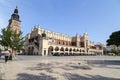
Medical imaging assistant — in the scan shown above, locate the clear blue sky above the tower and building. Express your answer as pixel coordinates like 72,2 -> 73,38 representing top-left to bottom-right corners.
0,0 -> 120,44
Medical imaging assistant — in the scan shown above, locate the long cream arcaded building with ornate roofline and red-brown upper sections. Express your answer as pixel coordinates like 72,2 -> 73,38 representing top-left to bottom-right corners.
25,26 -> 103,56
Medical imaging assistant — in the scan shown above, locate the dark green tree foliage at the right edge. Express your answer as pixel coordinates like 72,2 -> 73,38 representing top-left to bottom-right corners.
106,31 -> 120,47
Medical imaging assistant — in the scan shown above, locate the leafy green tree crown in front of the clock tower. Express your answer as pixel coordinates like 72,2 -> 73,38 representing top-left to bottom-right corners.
0,28 -> 24,50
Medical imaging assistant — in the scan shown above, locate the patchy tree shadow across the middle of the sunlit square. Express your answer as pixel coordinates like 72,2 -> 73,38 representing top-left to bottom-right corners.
27,63 -> 92,73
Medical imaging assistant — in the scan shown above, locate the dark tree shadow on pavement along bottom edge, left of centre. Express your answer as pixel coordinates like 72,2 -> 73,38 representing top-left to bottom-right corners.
17,73 -> 56,80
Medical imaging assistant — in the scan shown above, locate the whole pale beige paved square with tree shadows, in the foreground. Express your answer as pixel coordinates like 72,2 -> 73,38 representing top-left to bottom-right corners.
0,56 -> 120,80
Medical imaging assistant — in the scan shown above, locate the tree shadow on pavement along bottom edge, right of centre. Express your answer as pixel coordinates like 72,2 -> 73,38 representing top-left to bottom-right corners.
63,73 -> 120,80
